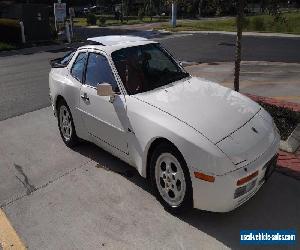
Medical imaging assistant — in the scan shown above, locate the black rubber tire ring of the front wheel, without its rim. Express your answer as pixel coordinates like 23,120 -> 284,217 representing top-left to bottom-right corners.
150,143 -> 193,214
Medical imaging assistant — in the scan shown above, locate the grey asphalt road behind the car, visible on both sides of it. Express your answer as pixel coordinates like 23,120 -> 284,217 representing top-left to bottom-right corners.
0,31 -> 300,120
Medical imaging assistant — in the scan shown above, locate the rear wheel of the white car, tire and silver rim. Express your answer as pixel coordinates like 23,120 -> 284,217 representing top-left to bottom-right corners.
57,101 -> 79,148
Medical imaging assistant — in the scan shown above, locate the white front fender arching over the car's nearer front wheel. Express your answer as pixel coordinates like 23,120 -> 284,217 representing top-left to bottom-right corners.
126,94 -> 234,176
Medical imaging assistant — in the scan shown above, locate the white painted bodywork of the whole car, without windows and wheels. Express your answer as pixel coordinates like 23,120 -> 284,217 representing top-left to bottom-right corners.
49,38 -> 279,212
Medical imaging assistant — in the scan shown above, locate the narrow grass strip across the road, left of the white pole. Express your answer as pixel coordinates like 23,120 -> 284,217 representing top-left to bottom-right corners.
74,17 -> 166,27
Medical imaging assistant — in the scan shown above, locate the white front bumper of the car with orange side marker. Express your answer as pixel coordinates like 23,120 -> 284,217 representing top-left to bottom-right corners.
191,131 -> 280,212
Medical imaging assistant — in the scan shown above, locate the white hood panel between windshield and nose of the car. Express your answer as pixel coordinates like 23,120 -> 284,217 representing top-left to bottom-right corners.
135,77 -> 260,144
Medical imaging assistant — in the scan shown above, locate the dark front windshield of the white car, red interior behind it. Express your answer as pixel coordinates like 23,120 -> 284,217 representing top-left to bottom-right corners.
112,44 -> 189,95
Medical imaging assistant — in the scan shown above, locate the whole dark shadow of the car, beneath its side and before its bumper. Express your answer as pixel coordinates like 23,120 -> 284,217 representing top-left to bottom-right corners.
75,142 -> 300,249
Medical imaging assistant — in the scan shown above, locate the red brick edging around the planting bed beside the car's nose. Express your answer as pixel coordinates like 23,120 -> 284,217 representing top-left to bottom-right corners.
246,94 -> 300,180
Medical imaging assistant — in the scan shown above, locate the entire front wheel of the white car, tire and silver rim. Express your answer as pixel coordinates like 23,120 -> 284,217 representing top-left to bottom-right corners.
150,143 -> 193,214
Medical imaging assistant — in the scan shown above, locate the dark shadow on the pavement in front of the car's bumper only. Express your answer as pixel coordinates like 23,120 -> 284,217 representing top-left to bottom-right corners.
178,172 -> 300,249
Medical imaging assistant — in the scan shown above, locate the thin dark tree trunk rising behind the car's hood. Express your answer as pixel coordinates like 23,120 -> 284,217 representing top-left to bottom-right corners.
234,0 -> 245,91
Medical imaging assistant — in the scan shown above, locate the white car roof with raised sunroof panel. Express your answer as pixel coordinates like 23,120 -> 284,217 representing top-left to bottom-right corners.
78,35 -> 157,54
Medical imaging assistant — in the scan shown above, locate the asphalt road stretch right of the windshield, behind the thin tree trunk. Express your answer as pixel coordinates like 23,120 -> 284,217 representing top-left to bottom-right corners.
162,34 -> 300,63
